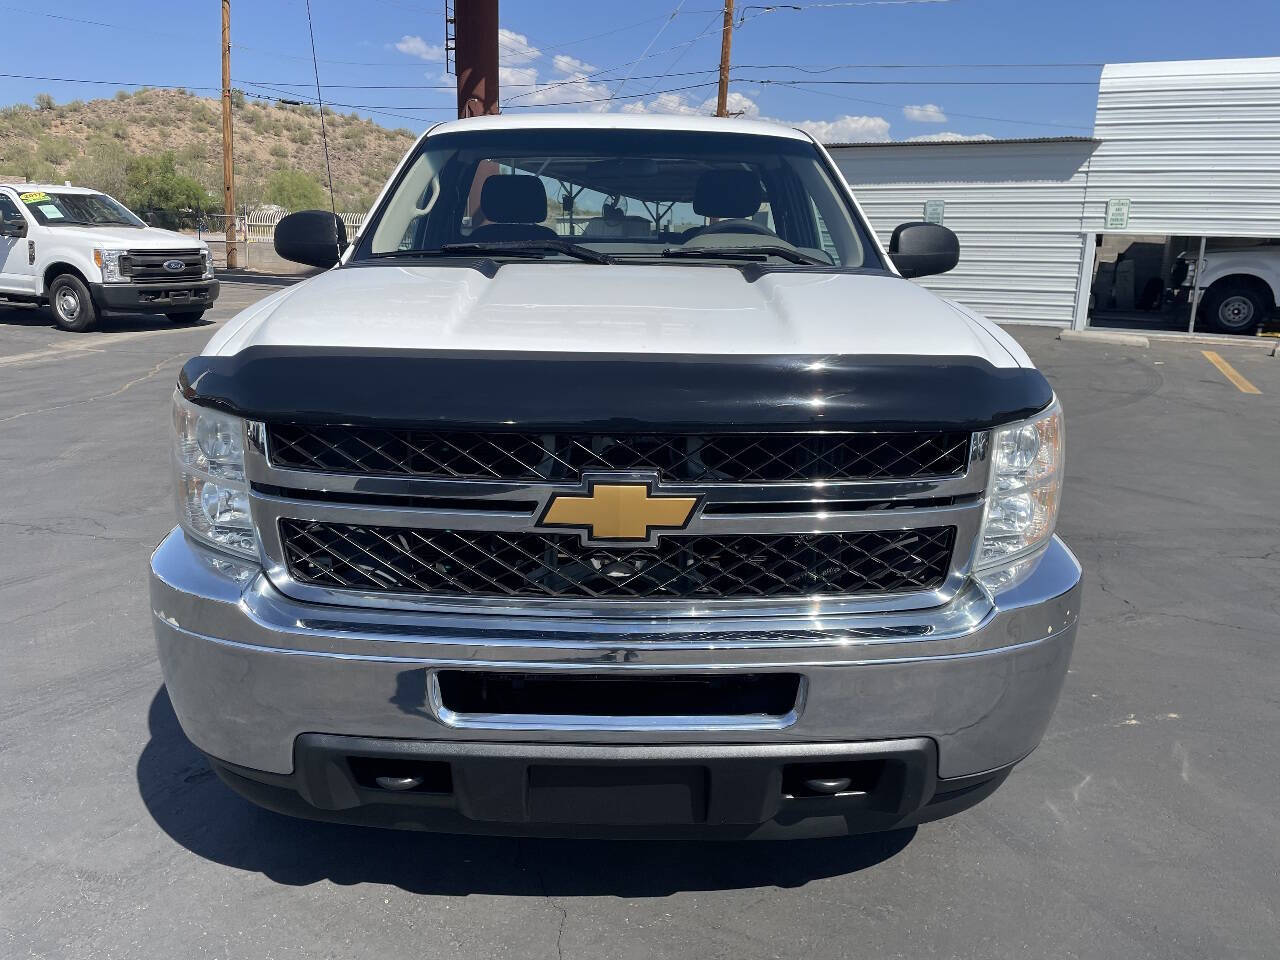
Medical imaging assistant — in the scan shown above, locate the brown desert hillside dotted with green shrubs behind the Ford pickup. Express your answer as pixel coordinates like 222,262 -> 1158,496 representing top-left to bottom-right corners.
0,90 -> 413,212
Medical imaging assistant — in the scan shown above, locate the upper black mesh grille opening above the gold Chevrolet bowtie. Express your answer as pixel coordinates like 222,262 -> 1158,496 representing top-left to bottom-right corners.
269,424 -> 969,483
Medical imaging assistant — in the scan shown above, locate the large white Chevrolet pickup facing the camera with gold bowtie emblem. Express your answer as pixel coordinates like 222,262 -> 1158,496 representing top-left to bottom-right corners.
151,114 -> 1080,837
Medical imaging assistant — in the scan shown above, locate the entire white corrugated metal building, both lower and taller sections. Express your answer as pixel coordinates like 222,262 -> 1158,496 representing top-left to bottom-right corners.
828,58 -> 1280,335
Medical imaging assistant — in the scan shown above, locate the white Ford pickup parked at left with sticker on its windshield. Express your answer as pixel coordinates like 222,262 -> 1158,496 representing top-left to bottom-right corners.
0,183 -> 218,333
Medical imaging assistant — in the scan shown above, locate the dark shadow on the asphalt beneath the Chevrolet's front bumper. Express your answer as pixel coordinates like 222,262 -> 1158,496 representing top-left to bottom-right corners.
137,687 -> 915,897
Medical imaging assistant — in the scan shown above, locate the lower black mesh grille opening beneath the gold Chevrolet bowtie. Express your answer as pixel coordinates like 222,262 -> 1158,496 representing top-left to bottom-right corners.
279,518 -> 955,599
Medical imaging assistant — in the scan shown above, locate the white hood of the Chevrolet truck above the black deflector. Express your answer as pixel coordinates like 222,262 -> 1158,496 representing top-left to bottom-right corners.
205,262 -> 1020,367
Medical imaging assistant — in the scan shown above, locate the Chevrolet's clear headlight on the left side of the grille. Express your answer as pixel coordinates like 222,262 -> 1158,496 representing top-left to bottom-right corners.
173,392 -> 257,559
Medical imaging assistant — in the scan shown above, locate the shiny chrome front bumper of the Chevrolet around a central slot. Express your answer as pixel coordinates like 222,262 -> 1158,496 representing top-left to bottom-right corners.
151,530 -> 1080,778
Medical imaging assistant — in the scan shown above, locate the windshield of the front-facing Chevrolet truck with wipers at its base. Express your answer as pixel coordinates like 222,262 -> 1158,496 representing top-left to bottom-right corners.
353,129 -> 883,270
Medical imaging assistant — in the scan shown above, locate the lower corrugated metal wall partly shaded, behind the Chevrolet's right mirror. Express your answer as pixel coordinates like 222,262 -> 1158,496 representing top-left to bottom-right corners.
828,140 -> 1096,325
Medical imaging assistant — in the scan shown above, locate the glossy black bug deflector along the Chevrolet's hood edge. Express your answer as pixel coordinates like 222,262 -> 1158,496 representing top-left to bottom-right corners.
178,346 -> 1053,433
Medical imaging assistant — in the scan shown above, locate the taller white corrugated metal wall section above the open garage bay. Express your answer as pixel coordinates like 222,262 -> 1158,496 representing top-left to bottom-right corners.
1085,58 -> 1280,237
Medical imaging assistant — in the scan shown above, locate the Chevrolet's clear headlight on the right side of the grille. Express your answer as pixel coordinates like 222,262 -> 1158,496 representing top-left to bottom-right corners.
975,399 -> 1064,570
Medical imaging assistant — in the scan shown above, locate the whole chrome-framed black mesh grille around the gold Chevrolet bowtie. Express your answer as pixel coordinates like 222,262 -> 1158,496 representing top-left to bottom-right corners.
246,422 -> 989,618
